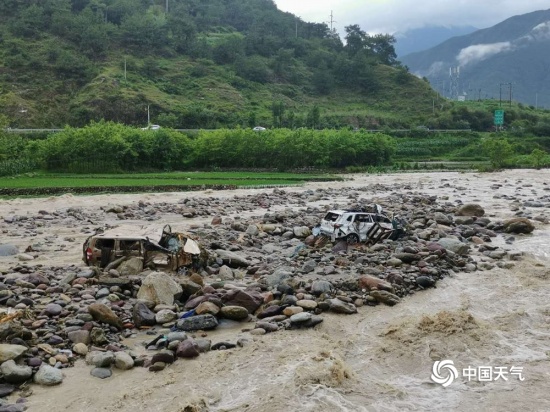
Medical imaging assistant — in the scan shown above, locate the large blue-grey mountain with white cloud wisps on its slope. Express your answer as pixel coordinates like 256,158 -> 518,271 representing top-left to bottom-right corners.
401,9 -> 550,108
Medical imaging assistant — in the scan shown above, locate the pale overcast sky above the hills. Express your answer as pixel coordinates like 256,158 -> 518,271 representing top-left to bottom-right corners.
274,0 -> 550,37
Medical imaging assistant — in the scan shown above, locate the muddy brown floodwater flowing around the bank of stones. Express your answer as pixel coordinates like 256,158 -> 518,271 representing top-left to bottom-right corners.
0,170 -> 550,412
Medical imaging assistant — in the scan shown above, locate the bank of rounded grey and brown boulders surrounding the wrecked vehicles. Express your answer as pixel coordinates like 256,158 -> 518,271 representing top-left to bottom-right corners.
0,176 -> 548,406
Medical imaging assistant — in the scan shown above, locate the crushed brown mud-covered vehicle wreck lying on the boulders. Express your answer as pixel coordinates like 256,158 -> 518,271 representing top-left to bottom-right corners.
82,225 -> 208,272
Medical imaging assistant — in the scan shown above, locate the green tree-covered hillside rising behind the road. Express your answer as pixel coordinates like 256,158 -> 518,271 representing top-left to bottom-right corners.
0,0 -> 440,128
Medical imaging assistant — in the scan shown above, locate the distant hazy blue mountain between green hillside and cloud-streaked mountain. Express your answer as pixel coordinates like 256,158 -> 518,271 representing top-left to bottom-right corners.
394,26 -> 478,58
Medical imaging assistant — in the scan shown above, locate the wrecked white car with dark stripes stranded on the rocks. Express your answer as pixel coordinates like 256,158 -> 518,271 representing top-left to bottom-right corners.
314,205 -> 406,244
